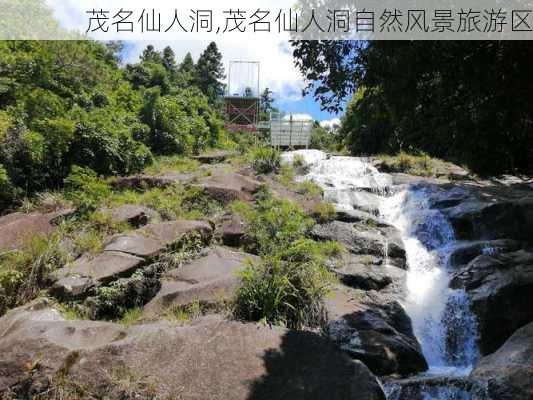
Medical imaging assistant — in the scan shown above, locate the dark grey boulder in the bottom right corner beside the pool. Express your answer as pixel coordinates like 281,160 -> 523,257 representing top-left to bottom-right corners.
470,323 -> 533,400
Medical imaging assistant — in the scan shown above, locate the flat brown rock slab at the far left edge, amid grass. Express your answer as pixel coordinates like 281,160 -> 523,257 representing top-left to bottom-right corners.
0,210 -> 72,251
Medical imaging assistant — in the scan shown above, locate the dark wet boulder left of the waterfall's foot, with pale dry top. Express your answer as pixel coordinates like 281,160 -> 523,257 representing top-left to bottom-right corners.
326,288 -> 428,376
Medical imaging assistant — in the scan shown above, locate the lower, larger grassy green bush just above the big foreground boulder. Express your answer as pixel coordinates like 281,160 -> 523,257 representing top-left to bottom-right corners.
235,239 -> 341,329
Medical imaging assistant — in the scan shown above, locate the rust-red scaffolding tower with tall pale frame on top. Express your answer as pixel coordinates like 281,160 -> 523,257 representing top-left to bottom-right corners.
224,61 -> 261,132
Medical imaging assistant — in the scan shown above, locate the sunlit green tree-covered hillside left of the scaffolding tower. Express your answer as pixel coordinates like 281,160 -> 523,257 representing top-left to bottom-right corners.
0,41 -> 223,208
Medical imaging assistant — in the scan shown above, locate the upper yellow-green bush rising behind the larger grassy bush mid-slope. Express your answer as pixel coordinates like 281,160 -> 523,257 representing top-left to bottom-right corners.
234,196 -> 313,255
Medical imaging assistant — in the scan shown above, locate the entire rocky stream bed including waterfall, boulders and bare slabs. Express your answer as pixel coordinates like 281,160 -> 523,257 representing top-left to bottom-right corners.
0,150 -> 533,400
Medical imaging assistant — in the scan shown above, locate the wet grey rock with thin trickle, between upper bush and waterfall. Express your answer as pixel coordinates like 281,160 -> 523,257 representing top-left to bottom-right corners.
311,221 -> 406,268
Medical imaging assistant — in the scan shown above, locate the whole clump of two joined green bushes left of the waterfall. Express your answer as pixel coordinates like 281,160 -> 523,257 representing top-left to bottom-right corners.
234,192 -> 342,329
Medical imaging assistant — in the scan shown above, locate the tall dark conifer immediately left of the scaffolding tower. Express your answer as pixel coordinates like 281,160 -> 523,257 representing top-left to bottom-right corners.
195,42 -> 226,104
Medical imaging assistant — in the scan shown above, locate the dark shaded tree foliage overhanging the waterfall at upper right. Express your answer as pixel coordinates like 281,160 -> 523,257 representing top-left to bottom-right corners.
294,40 -> 533,174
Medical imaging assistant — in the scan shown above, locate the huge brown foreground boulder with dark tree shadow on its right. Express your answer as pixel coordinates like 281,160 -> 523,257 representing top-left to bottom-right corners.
0,304 -> 385,400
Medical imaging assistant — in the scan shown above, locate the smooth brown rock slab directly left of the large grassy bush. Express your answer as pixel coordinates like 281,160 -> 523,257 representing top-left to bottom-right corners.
144,246 -> 257,316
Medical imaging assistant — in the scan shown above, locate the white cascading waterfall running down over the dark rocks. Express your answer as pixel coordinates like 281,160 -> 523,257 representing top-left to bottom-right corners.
283,150 -> 478,400
